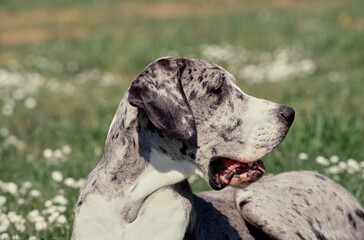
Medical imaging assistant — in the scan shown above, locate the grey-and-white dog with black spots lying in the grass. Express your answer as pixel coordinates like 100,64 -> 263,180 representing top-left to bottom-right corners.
72,57 -> 364,240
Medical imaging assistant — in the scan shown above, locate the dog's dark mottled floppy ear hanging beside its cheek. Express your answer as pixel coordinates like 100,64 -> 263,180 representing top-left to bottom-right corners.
128,58 -> 196,140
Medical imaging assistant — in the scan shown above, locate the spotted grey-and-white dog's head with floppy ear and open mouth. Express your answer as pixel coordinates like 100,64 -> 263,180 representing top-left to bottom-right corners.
129,57 -> 294,190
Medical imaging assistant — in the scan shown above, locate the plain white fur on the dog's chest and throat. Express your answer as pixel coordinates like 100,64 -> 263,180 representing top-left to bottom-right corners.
74,149 -> 198,240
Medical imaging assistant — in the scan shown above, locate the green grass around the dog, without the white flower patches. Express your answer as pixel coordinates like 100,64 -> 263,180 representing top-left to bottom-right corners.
0,0 -> 364,239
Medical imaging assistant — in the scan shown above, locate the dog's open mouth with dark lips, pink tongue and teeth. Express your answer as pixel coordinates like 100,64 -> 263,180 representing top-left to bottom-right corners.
209,157 -> 267,190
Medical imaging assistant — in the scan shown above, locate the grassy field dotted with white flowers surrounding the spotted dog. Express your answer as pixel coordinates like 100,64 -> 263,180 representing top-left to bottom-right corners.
0,0 -> 364,239
